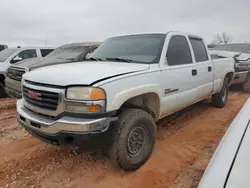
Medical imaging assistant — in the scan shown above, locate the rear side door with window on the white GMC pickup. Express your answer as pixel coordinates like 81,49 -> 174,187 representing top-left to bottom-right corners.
189,36 -> 214,101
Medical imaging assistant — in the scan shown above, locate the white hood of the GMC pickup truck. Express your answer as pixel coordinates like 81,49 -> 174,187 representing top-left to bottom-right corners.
23,61 -> 149,86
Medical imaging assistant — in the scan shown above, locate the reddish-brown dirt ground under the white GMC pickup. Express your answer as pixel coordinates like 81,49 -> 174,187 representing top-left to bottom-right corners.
0,91 -> 248,188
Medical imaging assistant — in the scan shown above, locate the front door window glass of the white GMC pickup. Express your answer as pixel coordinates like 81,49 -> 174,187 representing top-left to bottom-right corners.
167,35 -> 193,66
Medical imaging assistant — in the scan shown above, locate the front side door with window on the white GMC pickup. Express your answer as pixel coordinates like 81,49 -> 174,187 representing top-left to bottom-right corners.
162,35 -> 197,116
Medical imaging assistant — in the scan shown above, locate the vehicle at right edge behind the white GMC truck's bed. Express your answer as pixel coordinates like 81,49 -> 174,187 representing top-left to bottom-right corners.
211,43 -> 250,92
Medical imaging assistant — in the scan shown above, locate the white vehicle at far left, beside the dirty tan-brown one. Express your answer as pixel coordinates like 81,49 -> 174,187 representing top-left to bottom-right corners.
0,47 -> 54,98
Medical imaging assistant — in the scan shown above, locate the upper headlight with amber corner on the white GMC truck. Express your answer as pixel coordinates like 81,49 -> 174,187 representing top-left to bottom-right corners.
66,87 -> 106,101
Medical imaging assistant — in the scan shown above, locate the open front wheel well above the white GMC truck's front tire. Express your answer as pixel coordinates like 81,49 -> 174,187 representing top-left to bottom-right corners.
121,93 -> 160,119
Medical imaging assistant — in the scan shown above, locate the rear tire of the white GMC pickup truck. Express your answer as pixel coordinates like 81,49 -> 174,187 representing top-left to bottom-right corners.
212,77 -> 228,108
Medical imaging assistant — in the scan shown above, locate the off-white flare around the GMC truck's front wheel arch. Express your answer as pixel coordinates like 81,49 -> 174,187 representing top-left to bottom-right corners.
112,84 -> 162,109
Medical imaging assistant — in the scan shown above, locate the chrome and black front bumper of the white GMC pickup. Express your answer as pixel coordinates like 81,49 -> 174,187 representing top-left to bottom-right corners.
17,99 -> 117,148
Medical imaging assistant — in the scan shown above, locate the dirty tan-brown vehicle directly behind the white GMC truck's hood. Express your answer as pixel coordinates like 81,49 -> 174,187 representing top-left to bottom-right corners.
5,42 -> 100,98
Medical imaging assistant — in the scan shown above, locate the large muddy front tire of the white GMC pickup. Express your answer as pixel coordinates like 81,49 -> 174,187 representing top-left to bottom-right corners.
109,109 -> 156,171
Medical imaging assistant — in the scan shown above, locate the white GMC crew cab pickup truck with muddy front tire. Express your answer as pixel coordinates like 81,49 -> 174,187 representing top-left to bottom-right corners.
17,32 -> 234,171
